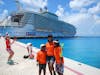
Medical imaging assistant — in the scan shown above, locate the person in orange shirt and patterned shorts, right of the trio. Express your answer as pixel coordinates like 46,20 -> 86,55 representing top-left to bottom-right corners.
54,41 -> 64,75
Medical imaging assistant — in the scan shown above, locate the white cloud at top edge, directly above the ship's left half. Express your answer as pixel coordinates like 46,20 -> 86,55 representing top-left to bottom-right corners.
19,0 -> 47,11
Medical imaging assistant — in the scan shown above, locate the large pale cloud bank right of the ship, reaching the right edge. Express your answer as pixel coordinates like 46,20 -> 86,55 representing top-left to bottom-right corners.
56,3 -> 100,36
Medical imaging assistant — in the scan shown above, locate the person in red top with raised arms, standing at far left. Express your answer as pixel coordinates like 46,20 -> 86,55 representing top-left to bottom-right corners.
5,36 -> 16,64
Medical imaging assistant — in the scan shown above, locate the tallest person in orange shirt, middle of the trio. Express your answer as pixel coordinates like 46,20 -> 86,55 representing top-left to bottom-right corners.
46,35 -> 56,75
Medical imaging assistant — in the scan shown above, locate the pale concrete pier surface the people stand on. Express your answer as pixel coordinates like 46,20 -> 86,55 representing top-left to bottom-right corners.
0,37 -> 100,75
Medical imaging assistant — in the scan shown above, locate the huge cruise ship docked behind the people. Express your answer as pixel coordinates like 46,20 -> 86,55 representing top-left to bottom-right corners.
0,1 -> 76,37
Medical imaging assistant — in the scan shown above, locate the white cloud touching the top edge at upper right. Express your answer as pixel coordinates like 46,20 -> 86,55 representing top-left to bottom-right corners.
69,0 -> 95,9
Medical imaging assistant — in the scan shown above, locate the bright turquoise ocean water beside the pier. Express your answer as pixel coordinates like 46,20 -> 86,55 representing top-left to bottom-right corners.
18,37 -> 100,69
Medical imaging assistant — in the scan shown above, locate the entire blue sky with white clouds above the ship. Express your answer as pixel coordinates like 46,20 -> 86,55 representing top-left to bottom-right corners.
0,0 -> 100,36
